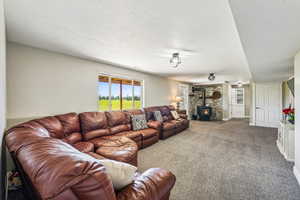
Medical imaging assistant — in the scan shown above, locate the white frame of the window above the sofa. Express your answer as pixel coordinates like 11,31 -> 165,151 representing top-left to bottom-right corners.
97,73 -> 145,112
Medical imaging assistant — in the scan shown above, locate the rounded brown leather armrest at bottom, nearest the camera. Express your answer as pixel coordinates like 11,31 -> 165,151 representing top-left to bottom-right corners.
117,168 -> 176,200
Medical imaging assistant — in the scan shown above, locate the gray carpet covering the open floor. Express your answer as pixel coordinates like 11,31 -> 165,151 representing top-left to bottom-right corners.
139,120 -> 300,200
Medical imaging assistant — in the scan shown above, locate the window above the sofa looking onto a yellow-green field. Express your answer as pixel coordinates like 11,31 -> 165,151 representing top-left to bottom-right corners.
98,76 -> 143,111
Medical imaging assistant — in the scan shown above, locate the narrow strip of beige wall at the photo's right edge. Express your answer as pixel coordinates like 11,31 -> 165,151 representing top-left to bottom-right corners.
294,52 -> 300,184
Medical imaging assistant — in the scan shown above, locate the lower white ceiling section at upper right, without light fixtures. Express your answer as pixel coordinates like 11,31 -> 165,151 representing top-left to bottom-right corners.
230,0 -> 300,81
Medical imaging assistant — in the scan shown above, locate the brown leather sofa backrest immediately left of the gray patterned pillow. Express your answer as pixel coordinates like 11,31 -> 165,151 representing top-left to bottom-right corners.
105,111 -> 131,134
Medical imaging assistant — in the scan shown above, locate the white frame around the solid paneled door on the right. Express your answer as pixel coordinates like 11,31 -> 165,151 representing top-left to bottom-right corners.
249,82 -> 282,128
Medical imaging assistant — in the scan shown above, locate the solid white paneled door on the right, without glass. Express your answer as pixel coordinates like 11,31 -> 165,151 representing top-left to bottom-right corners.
255,83 -> 281,127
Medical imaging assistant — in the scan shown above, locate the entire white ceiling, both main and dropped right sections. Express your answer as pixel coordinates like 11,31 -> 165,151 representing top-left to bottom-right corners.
5,0 -> 300,83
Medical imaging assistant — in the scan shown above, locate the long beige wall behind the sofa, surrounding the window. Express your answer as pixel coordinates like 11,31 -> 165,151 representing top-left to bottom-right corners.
7,43 -> 178,119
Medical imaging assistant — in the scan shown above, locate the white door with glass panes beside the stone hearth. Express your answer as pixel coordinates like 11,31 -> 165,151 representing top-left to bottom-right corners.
231,88 -> 245,118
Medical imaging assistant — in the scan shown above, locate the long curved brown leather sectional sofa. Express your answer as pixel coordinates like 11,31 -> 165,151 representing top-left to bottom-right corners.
6,106 -> 189,200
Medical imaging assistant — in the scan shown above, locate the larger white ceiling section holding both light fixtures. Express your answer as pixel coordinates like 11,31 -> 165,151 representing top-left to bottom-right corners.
5,0 -> 251,82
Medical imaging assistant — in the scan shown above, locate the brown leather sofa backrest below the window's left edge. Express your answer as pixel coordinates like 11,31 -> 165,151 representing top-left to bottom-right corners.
79,112 -> 110,140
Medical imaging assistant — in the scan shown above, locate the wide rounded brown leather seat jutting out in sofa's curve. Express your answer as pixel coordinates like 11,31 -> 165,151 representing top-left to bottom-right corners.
96,137 -> 138,166
